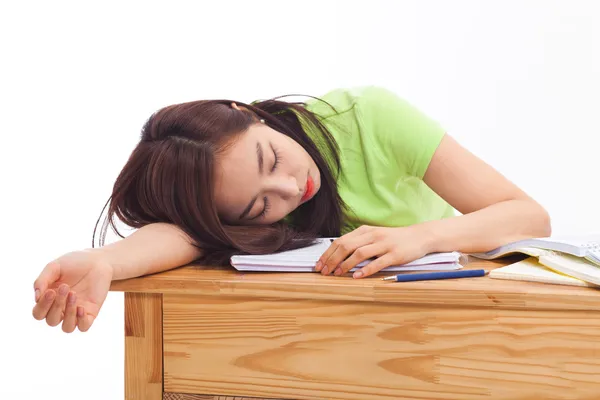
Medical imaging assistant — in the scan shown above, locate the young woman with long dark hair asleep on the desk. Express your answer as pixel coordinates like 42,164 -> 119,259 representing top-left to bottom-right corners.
33,87 -> 550,332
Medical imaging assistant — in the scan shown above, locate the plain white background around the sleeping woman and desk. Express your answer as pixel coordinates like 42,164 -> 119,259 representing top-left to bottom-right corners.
0,0 -> 600,400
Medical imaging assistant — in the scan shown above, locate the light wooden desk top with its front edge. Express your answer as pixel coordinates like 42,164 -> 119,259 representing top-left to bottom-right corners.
111,257 -> 600,311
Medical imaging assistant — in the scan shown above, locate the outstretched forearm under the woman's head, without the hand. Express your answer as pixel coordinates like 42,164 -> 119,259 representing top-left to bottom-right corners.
90,223 -> 201,280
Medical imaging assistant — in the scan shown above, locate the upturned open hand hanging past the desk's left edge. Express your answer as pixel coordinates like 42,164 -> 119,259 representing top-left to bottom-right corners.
33,251 -> 113,333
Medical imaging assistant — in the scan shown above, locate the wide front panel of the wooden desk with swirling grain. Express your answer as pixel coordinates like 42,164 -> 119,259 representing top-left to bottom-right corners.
163,294 -> 600,400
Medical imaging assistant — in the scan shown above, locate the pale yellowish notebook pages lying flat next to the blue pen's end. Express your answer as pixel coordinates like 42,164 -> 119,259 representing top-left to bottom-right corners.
489,257 -> 600,288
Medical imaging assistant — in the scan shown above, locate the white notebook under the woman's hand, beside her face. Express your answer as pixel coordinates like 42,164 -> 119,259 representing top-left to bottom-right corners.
231,238 -> 462,272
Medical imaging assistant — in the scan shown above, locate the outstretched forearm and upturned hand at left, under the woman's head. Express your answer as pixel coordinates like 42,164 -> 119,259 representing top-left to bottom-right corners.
32,223 -> 201,333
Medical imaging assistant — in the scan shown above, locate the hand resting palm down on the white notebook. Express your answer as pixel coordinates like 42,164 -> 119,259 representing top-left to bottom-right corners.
316,225 -> 430,278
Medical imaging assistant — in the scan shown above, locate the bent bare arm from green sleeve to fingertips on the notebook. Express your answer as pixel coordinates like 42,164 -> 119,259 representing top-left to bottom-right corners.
317,135 -> 551,278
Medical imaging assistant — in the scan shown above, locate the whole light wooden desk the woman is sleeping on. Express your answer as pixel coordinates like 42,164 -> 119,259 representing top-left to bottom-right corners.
111,259 -> 600,400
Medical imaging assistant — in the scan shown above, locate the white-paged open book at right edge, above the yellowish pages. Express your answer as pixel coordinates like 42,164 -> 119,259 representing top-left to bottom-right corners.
471,233 -> 600,266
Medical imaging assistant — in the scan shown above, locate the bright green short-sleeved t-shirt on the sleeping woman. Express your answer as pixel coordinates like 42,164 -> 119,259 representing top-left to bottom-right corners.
306,86 -> 454,233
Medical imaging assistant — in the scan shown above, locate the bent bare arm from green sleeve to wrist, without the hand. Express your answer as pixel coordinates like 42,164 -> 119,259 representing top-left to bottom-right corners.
418,135 -> 551,253
